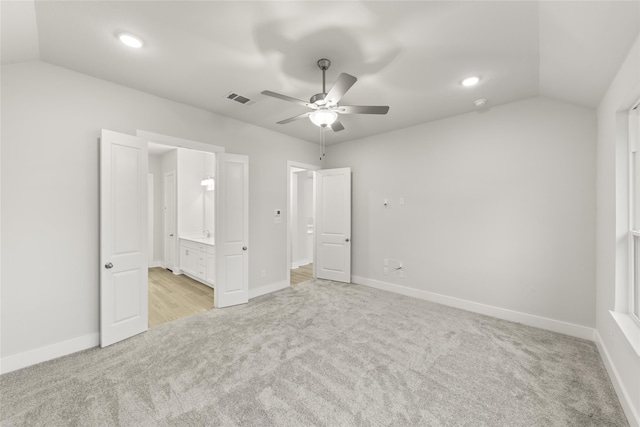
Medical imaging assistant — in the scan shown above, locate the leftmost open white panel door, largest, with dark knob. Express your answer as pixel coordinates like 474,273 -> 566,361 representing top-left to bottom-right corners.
100,129 -> 148,347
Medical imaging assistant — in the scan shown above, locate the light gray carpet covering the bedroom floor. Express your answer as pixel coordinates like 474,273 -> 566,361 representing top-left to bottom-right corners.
0,281 -> 628,426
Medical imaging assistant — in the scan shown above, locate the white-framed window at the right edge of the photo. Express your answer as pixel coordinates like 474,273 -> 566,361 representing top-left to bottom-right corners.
628,102 -> 640,325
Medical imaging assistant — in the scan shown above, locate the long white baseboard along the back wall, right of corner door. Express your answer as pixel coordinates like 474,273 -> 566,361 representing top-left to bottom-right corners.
351,276 -> 594,341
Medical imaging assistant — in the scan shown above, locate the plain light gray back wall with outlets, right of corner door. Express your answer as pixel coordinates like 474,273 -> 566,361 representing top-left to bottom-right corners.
327,97 -> 596,327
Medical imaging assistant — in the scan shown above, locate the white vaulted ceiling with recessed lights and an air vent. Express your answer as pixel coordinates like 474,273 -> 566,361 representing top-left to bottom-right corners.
0,0 -> 640,144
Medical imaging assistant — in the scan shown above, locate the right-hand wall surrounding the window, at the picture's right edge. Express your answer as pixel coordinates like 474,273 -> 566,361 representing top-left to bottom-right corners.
596,38 -> 640,425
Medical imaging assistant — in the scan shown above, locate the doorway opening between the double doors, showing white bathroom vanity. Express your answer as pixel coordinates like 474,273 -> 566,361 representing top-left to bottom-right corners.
148,142 -> 215,328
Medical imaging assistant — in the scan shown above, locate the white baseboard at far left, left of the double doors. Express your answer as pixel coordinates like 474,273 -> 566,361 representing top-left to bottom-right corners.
0,332 -> 100,374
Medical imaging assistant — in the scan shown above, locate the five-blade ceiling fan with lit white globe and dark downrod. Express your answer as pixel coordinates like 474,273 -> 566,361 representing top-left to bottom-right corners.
261,58 -> 389,132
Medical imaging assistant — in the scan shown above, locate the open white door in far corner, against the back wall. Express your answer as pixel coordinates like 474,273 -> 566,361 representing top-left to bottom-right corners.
314,168 -> 351,283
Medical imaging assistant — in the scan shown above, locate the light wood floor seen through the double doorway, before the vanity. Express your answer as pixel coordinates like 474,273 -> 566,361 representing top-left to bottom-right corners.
149,267 -> 213,328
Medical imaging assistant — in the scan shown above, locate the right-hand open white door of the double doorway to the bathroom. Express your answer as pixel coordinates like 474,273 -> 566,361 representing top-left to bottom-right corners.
213,153 -> 249,308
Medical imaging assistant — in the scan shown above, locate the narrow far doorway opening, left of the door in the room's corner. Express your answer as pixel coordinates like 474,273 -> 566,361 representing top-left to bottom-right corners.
287,161 -> 320,285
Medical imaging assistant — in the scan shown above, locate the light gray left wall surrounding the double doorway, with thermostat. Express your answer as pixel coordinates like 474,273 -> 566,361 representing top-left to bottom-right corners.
1,62 -> 318,360
